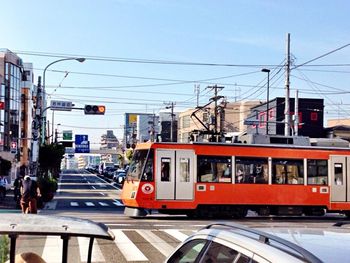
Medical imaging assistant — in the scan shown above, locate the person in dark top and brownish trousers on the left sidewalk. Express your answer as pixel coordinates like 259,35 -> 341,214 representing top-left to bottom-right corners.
21,175 -> 41,214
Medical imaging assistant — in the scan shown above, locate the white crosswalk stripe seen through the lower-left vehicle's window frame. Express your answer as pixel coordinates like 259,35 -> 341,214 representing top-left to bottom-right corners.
41,236 -> 63,263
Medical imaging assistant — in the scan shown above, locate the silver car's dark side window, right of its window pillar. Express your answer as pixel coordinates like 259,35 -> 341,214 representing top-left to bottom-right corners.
201,242 -> 239,263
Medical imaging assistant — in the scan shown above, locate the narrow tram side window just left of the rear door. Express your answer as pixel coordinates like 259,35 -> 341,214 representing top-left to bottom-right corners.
307,160 -> 328,185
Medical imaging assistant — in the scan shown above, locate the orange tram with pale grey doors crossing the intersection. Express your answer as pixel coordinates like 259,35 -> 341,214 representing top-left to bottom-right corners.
122,138 -> 350,218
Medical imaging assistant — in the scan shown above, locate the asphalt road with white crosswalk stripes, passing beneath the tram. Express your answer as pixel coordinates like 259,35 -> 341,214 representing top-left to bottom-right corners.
4,171 -> 345,263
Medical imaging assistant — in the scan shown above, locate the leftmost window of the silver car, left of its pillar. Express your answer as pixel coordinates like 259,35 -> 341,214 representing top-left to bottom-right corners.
167,239 -> 207,263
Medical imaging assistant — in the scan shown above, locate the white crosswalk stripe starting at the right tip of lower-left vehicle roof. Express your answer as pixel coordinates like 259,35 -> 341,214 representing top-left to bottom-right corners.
112,229 -> 148,261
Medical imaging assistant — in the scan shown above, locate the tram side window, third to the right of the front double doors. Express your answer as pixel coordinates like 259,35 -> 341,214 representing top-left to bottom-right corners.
272,159 -> 304,184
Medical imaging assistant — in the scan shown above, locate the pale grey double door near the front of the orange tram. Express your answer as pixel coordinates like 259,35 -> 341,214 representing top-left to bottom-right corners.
156,149 -> 194,200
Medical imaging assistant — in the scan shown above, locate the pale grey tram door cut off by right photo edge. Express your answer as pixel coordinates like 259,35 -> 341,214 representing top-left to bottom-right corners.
330,156 -> 350,202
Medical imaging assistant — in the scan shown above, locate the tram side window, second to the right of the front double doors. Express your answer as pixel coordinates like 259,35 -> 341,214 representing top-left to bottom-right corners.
235,157 -> 268,184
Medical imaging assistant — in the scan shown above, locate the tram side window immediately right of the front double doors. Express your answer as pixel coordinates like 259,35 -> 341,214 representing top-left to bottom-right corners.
197,155 -> 232,183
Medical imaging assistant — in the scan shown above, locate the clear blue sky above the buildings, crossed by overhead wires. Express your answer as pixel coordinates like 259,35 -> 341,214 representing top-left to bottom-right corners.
0,0 -> 350,143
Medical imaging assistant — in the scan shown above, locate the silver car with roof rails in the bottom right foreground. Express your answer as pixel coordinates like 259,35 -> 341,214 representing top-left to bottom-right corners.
166,223 -> 350,263
